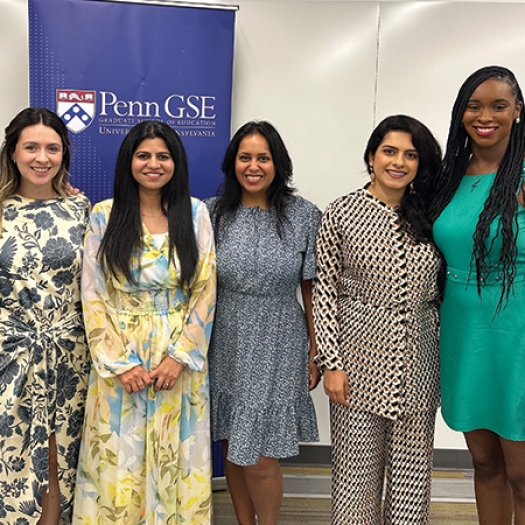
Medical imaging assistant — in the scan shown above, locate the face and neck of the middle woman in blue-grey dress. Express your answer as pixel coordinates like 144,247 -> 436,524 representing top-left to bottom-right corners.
235,134 -> 275,207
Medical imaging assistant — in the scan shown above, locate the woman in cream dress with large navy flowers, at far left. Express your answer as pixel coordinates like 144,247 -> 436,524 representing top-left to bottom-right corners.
0,108 -> 90,525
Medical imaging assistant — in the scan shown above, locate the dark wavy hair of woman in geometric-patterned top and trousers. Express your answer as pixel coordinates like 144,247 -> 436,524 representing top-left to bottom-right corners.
363,115 -> 442,242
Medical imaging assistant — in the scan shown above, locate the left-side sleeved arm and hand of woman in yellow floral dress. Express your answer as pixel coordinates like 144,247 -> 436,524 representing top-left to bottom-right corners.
82,203 -> 151,386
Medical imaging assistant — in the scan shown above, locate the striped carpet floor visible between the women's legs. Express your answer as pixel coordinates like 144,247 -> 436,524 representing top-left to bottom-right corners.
213,467 -> 477,525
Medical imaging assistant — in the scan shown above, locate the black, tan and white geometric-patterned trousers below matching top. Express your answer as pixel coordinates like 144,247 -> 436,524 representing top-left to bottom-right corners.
330,402 -> 436,525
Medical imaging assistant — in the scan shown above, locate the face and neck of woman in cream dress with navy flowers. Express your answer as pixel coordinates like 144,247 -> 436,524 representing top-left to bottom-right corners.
11,124 -> 64,199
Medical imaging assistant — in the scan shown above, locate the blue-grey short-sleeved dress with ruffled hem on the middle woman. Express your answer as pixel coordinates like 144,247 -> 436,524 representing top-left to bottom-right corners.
207,197 -> 321,466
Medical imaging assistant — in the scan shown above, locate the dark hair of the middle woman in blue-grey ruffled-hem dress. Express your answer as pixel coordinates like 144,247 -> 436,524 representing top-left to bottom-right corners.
212,120 -> 295,235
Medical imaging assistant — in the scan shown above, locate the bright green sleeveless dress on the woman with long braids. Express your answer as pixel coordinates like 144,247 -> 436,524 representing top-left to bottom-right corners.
434,173 -> 525,441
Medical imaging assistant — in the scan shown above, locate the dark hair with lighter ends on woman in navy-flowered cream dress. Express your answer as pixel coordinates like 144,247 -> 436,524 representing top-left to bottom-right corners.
0,108 -> 71,204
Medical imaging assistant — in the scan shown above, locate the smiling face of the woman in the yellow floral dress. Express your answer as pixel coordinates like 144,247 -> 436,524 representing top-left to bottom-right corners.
131,137 -> 175,194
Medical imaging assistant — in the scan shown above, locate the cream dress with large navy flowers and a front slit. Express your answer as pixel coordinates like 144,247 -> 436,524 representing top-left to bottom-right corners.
0,195 -> 90,525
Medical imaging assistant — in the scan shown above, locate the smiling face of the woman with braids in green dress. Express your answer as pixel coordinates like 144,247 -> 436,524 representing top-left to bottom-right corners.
462,78 -> 521,156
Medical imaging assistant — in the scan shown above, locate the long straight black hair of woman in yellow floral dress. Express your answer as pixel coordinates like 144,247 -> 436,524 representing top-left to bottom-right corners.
99,120 -> 199,284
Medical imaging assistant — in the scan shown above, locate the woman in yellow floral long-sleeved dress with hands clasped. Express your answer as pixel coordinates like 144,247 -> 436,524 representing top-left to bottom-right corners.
73,121 -> 215,525
